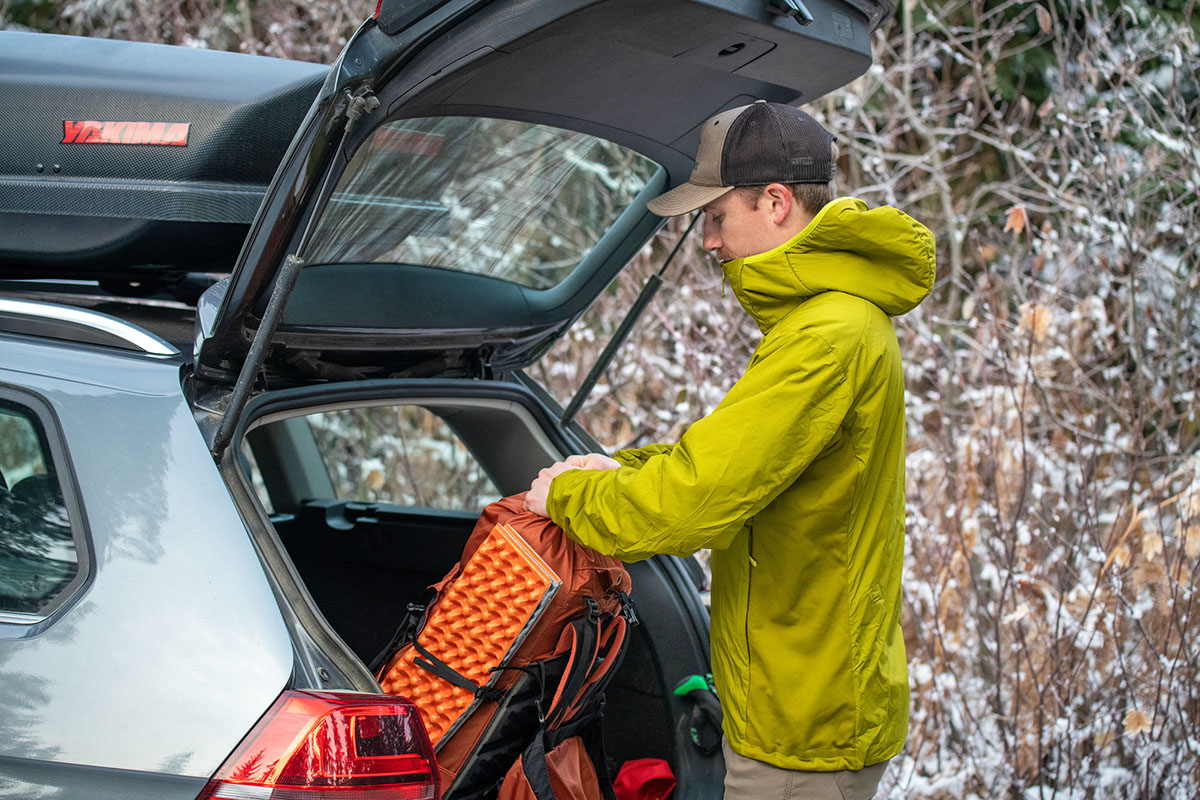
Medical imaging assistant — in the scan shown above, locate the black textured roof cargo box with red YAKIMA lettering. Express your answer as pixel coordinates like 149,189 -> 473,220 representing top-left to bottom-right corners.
0,31 -> 329,289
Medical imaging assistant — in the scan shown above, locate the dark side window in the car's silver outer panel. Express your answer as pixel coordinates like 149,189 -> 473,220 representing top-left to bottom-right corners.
0,398 -> 82,615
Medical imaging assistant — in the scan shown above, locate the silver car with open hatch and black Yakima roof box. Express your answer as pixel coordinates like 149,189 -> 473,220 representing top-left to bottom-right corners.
0,0 -> 892,800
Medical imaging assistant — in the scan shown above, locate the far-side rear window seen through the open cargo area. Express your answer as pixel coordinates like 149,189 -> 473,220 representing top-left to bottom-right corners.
306,405 -> 502,511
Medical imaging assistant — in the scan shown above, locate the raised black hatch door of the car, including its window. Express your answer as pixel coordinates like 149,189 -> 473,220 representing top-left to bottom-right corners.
187,0 -> 886,398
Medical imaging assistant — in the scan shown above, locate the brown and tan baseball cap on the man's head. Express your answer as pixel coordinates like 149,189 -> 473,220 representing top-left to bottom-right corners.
647,100 -> 838,217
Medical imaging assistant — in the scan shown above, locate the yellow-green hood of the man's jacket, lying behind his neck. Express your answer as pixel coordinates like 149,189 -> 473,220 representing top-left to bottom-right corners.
721,197 -> 936,333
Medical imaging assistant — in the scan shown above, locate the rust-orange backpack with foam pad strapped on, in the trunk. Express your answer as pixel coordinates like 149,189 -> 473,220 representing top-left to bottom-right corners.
372,494 -> 636,800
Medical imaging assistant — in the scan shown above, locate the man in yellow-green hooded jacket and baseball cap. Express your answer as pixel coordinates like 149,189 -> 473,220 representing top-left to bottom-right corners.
526,101 -> 935,800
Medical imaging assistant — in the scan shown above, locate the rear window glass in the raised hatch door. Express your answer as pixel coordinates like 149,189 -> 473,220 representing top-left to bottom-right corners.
306,116 -> 659,289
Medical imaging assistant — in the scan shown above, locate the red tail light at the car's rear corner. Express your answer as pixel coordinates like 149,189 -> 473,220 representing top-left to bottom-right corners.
197,691 -> 440,800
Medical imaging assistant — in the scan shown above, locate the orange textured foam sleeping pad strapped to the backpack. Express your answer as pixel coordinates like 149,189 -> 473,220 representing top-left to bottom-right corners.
380,523 -> 562,746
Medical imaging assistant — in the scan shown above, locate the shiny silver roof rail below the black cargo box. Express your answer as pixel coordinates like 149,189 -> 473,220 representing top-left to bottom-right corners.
0,297 -> 179,355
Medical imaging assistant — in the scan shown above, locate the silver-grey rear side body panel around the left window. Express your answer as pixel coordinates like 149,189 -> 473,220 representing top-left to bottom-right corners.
0,337 -> 293,796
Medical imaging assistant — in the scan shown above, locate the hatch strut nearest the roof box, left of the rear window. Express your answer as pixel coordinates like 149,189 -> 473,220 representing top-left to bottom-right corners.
210,88 -> 379,462
